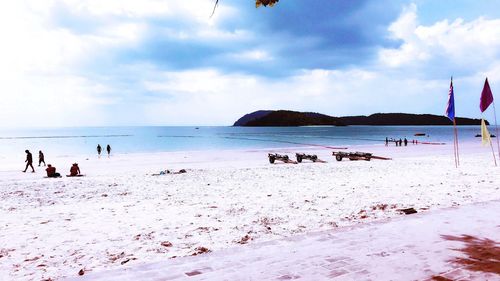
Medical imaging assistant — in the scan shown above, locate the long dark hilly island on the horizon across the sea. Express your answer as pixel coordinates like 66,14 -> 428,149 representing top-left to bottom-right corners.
233,110 -> 489,127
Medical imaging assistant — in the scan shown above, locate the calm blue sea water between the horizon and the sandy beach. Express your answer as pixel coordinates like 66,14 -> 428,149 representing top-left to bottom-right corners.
0,126 -> 484,159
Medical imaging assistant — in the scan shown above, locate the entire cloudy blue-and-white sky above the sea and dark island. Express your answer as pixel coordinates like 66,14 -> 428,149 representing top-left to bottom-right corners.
0,0 -> 500,124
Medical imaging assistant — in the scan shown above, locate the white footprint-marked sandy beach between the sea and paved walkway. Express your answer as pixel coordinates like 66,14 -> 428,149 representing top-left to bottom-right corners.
0,141 -> 500,280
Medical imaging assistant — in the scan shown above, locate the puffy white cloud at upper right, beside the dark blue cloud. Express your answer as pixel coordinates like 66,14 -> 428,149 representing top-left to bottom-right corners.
379,4 -> 500,68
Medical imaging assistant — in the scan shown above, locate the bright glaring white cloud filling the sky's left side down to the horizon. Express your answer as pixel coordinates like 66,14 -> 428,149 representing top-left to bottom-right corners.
0,1 -> 147,126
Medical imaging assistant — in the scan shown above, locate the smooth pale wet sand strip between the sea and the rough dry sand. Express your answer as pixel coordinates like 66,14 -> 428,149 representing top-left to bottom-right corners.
0,138 -> 491,171
